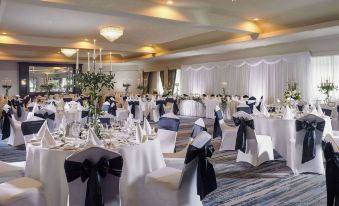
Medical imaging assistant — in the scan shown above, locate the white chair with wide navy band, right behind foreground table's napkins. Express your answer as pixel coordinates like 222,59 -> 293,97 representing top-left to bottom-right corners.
157,113 -> 180,153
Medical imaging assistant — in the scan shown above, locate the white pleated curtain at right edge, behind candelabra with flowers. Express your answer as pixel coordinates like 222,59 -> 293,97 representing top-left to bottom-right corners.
310,55 -> 339,101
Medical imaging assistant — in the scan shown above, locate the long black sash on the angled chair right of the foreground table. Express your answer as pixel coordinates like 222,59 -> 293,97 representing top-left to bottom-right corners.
185,145 -> 217,200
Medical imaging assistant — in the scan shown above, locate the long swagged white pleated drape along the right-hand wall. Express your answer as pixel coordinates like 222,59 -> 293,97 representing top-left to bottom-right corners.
180,52 -> 311,102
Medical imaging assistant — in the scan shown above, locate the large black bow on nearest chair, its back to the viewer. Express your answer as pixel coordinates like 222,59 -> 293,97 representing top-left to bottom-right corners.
64,156 -> 123,206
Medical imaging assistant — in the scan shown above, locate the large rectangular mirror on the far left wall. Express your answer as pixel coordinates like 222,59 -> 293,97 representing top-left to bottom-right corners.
28,66 -> 73,93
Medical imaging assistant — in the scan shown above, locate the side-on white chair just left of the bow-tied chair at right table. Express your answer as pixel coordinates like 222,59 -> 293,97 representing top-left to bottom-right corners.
213,106 -> 237,151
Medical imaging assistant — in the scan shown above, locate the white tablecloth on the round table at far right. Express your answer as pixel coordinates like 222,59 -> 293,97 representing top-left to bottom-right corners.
254,117 -> 333,161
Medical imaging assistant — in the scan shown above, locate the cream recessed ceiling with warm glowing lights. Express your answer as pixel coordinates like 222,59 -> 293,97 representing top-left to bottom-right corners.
0,0 -> 339,63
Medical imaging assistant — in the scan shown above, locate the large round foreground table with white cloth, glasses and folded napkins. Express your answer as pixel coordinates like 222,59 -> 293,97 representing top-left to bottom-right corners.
26,131 -> 165,206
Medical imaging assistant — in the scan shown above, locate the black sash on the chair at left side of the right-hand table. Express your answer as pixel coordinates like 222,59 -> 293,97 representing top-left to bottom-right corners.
233,117 -> 254,153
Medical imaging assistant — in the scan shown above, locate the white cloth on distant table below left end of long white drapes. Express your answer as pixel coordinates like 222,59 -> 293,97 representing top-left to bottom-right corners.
179,100 -> 206,117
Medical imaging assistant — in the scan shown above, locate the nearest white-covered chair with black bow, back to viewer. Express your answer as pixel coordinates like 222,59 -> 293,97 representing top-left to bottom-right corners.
64,147 -> 123,206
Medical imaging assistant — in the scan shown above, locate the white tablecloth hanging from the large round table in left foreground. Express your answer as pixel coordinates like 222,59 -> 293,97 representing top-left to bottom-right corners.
26,139 -> 164,206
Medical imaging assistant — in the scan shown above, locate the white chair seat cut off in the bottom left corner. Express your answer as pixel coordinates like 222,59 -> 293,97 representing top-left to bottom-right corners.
0,177 -> 46,206
